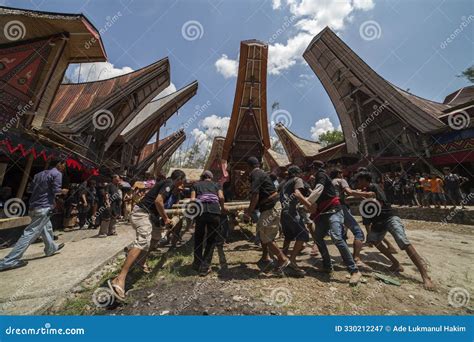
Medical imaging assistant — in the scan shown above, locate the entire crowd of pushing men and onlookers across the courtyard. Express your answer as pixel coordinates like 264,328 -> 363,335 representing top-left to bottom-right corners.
4,157 -> 465,299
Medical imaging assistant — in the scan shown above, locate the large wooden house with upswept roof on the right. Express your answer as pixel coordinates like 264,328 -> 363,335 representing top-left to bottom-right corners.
303,27 -> 474,172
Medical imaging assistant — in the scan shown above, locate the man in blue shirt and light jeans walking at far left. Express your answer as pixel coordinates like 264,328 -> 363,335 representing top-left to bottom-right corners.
0,161 -> 67,271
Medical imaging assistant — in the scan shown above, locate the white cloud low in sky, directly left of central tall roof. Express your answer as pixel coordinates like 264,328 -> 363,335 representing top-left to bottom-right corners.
191,114 -> 230,153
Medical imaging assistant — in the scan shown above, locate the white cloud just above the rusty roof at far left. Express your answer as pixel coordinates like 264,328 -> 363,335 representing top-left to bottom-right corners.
68,62 -> 133,82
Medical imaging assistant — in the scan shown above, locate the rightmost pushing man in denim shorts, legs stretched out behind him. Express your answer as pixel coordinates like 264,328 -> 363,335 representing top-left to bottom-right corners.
356,172 -> 434,290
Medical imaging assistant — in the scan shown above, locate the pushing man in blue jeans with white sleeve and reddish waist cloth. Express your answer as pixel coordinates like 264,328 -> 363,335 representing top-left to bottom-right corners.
308,160 -> 362,286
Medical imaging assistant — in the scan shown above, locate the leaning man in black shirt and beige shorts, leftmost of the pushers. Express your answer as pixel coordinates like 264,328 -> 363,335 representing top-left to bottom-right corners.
108,170 -> 186,300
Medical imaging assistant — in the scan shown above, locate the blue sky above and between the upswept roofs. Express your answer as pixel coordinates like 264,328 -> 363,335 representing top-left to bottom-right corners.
7,0 -> 474,152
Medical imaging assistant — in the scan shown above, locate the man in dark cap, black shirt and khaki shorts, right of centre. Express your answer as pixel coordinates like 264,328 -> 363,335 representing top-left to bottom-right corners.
244,157 -> 290,274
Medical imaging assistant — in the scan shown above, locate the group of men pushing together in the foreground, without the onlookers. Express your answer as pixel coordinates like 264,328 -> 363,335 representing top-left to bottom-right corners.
108,157 -> 434,300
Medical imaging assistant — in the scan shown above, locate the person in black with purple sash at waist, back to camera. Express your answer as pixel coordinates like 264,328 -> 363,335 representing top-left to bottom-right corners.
190,170 -> 224,276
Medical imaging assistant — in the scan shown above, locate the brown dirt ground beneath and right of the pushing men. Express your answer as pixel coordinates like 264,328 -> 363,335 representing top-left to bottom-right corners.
50,220 -> 474,315
